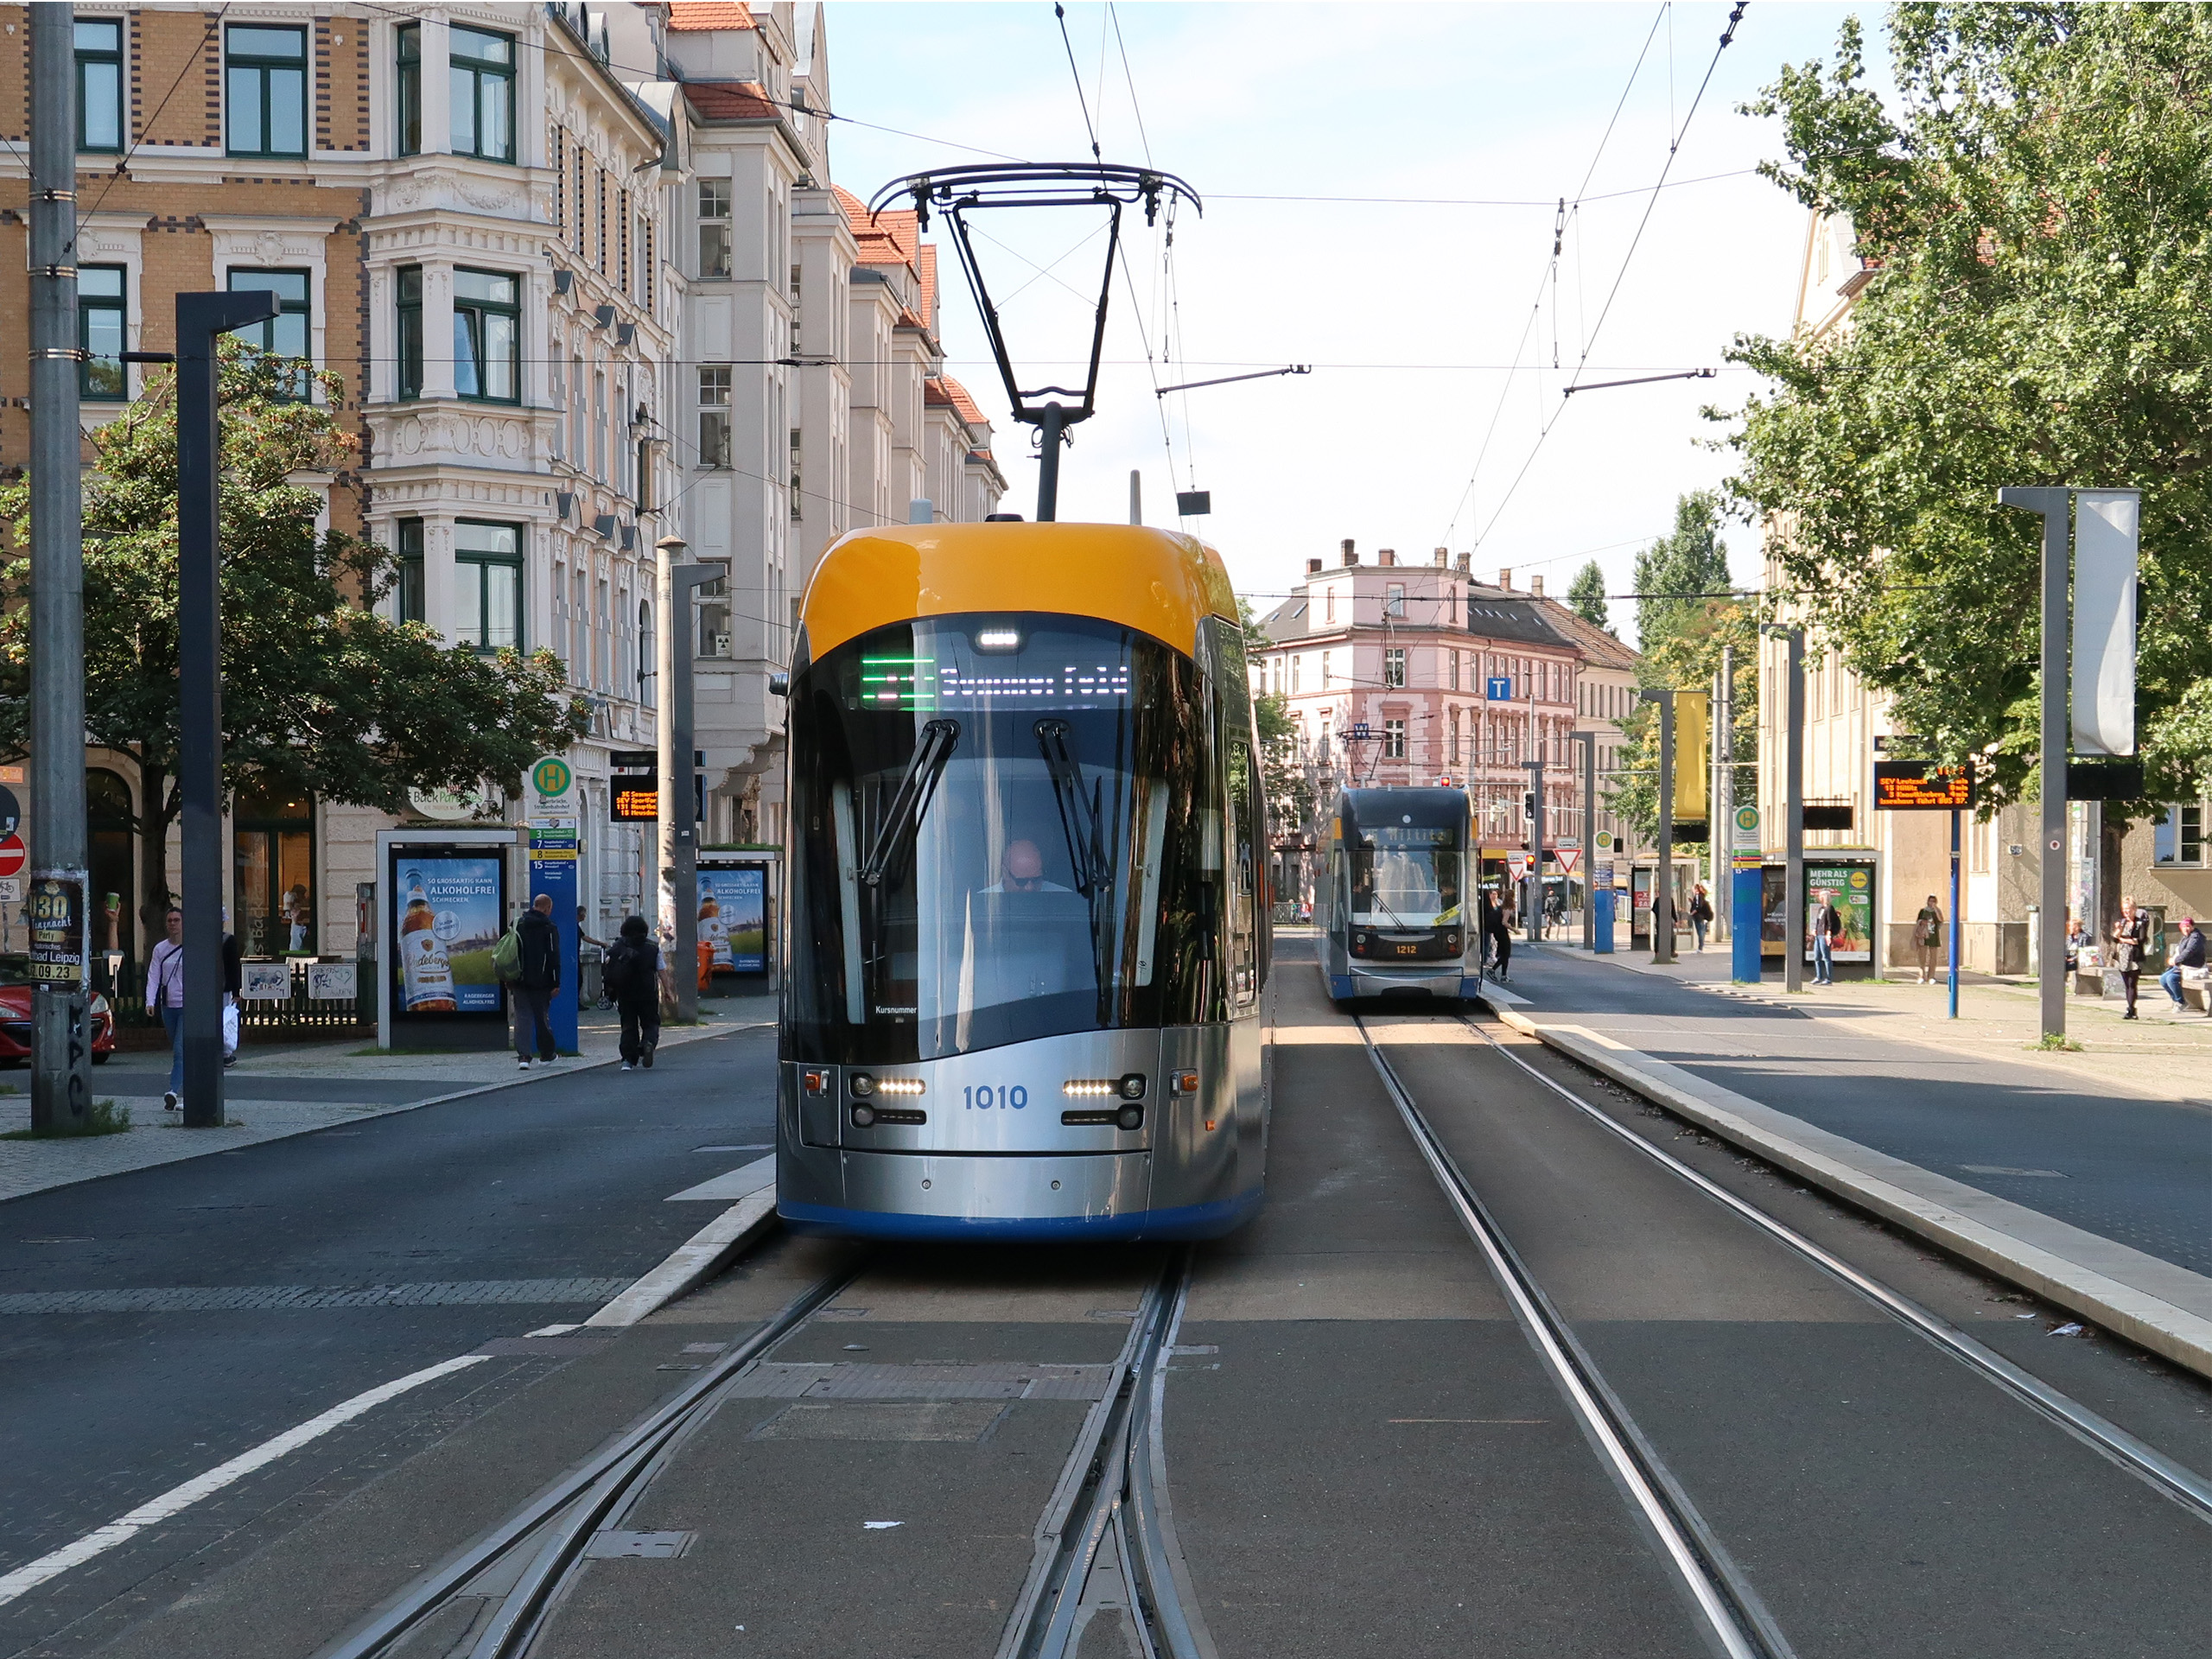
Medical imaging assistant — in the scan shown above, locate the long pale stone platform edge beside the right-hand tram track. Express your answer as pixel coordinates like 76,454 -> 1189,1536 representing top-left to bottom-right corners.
1489,1004 -> 2212,1376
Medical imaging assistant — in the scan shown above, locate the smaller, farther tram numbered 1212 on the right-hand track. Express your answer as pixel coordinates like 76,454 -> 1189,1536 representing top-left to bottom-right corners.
1320,790 -> 1482,1002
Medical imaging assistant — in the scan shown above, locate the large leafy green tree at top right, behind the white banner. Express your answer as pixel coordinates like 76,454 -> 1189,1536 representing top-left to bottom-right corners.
1730,4 -> 2212,810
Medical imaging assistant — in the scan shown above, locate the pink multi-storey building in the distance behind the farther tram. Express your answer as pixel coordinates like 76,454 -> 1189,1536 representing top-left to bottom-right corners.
1255,542 -> 1586,889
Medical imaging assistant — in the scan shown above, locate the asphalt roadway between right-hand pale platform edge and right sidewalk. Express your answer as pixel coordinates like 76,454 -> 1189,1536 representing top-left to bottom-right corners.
1510,951 -> 2212,1274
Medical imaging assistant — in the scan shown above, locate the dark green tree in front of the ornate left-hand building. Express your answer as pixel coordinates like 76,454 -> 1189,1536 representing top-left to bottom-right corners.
0,340 -> 588,942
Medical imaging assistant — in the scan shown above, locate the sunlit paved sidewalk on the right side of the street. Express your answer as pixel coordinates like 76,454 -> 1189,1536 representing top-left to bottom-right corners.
1516,940 -> 2212,1106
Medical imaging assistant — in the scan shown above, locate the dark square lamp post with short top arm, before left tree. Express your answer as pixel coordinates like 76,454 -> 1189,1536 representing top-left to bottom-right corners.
177,289 -> 276,1128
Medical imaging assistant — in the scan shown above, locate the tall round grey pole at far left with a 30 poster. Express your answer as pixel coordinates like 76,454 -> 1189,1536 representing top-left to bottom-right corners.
29,7 -> 93,1135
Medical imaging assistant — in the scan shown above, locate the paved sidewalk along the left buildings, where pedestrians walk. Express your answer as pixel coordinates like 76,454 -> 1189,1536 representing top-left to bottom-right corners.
0,998 -> 777,1201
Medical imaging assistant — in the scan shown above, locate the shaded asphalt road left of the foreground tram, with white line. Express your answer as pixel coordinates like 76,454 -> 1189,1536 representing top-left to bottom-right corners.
0,1031 -> 774,1655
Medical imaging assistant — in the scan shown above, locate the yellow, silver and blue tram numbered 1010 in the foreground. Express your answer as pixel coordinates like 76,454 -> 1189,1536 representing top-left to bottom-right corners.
777,522 -> 1269,1241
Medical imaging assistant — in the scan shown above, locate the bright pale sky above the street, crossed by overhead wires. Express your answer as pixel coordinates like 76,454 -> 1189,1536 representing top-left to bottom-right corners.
827,0 -> 1878,637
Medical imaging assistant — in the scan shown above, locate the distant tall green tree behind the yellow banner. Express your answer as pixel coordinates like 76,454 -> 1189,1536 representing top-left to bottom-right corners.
1608,489 -> 1758,845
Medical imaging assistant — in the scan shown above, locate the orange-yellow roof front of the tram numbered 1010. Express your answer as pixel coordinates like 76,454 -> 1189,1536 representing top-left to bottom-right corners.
801,524 -> 1236,657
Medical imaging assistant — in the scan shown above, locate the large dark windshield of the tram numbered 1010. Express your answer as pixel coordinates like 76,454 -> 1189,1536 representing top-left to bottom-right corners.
791,615 -> 1221,1062
